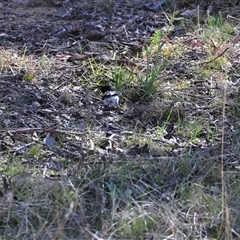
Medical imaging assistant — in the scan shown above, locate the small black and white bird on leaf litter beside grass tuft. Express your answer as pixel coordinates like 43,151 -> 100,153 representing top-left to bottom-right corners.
99,85 -> 119,108
